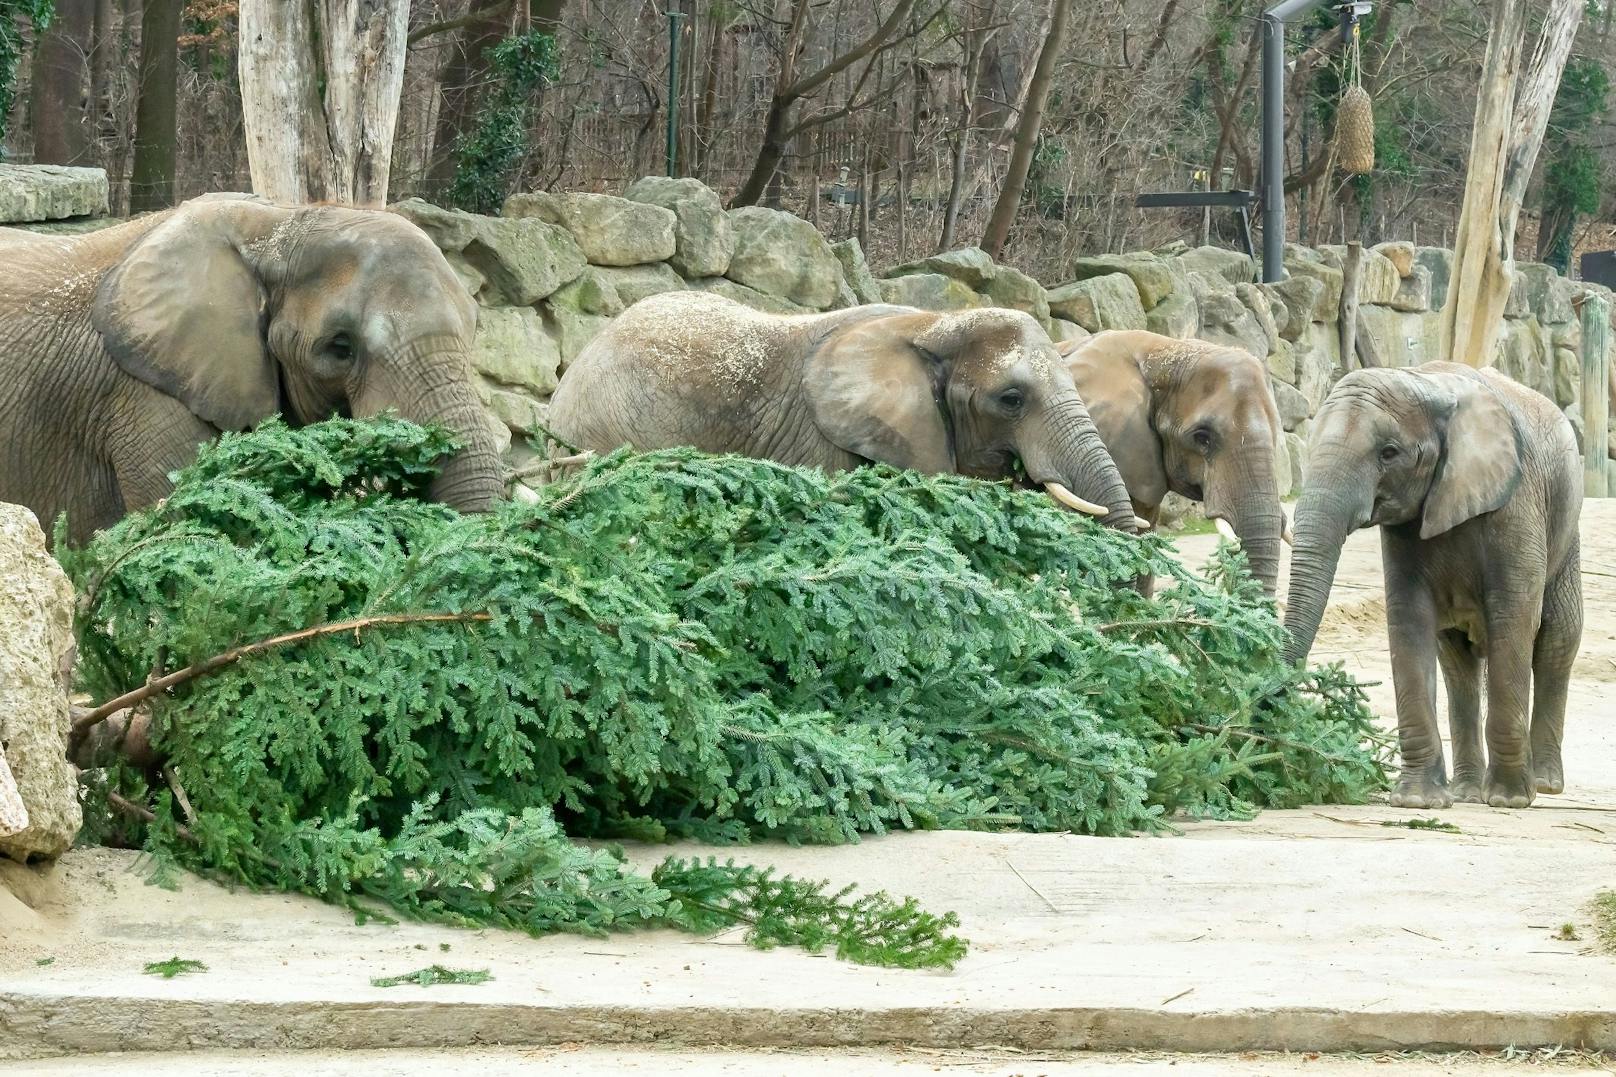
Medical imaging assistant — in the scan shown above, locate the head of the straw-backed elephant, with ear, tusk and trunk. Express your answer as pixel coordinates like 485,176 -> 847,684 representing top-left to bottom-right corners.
803,307 -> 1138,532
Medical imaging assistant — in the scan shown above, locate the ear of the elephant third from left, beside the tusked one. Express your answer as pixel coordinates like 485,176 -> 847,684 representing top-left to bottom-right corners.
1058,330 -> 1167,505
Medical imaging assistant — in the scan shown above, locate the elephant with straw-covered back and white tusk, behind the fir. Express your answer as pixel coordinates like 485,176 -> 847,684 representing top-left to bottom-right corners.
549,293 -> 1136,532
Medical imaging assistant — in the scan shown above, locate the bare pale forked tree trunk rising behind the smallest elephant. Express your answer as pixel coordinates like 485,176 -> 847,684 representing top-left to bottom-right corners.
1441,0 -> 1584,367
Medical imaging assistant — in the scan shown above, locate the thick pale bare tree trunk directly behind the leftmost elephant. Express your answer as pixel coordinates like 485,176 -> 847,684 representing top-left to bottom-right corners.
239,0 -> 409,205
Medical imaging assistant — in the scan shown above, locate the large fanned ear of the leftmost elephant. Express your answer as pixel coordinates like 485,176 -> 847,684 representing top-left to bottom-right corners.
90,197 -> 291,430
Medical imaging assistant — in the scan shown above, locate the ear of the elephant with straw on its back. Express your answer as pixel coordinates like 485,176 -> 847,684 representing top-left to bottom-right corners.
803,304 -> 957,474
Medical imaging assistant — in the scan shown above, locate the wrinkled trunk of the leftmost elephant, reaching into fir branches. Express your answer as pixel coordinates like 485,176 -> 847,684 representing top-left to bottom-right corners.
354,346 -> 504,513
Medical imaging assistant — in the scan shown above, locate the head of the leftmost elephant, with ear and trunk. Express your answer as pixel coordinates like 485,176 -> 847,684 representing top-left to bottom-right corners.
90,196 -> 503,511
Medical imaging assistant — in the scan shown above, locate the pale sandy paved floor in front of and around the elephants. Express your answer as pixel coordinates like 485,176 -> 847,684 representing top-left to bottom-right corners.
0,501 -> 1616,1054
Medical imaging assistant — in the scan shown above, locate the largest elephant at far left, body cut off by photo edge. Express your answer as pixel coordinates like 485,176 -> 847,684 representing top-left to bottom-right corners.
0,196 -> 501,542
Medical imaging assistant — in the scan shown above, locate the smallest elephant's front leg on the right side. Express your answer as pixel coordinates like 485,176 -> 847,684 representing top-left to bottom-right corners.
1482,589 -> 1543,809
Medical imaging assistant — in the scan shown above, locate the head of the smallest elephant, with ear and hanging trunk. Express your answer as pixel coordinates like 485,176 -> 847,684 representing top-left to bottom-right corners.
1285,362 -> 1522,661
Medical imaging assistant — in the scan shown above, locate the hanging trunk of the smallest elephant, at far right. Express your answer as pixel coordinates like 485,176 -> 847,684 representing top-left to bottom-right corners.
1285,461 -> 1372,663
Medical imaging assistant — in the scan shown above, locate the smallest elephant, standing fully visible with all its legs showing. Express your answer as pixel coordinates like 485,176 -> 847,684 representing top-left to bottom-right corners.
1285,362 -> 1582,809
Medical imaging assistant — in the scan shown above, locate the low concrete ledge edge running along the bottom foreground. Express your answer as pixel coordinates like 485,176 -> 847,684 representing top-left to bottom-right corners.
9,993 -> 1616,1058
